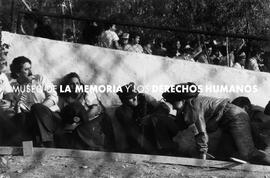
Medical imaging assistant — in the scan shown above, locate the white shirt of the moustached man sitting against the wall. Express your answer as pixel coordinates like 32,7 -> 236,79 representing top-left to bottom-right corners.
12,75 -> 59,111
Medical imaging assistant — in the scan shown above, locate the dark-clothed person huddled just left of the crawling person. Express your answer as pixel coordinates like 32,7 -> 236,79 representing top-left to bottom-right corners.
115,83 -> 179,154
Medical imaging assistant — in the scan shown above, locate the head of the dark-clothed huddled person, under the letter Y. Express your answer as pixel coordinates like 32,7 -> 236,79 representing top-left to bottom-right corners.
117,82 -> 139,107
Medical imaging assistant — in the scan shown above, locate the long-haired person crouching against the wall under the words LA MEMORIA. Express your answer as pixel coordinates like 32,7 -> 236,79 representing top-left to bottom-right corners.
58,72 -> 114,151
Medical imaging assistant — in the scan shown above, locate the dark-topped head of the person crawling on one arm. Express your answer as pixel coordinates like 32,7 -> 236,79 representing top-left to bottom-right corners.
162,82 -> 199,110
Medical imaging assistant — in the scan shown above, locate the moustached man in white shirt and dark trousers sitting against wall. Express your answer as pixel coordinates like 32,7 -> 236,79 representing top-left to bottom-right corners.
10,56 -> 60,147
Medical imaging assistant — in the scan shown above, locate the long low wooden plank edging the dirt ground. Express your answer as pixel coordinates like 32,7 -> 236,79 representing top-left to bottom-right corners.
0,147 -> 270,173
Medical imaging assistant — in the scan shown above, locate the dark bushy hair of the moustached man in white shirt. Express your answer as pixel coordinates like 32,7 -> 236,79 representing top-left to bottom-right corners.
10,56 -> 32,79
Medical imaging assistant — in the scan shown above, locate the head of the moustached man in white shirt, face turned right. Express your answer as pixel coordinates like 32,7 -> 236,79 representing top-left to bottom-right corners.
10,56 -> 33,82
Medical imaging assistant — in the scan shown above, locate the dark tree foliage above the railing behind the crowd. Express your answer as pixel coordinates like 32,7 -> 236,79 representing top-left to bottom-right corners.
0,0 -> 270,39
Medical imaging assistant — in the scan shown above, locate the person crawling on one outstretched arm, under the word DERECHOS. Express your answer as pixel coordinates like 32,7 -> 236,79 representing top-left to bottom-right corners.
162,83 -> 270,165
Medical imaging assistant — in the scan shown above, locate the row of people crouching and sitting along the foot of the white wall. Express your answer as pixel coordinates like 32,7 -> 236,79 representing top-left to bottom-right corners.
0,56 -> 270,165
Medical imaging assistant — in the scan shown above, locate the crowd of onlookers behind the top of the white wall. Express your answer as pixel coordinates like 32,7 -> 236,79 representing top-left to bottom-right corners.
22,16 -> 270,72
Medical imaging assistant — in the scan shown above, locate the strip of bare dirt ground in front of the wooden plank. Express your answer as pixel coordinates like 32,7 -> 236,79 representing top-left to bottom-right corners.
0,155 -> 270,178
